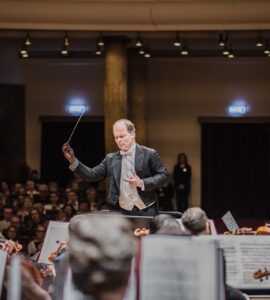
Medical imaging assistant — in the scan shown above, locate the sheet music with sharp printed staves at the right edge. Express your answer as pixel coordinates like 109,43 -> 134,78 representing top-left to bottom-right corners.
197,235 -> 270,289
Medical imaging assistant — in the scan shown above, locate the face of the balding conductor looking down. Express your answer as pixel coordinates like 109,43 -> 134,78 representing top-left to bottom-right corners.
113,122 -> 135,151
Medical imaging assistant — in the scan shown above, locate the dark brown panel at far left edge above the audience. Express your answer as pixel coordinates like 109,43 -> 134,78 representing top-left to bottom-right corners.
0,83 -> 26,183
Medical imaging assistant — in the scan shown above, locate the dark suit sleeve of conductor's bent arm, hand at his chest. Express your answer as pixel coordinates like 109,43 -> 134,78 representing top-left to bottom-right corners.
143,151 -> 169,191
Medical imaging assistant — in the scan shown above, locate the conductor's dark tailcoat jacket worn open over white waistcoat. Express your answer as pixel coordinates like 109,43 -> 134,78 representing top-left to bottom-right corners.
71,144 -> 168,209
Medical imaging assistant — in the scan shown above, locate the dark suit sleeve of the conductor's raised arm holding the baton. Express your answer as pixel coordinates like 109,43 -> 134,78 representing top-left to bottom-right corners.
74,157 -> 108,181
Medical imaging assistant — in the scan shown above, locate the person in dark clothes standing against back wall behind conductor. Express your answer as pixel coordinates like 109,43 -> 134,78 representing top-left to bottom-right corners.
173,153 -> 191,212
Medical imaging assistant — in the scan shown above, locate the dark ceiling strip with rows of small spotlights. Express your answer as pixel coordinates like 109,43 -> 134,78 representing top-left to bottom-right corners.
0,30 -> 270,59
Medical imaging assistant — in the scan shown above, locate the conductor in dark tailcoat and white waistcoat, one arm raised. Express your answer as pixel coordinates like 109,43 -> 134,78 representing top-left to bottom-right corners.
62,119 -> 168,216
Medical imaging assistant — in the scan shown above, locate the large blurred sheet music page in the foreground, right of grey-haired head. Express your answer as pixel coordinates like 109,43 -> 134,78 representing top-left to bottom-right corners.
140,235 -> 224,300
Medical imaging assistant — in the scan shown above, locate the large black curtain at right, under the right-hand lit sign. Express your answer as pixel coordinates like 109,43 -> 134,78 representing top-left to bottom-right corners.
201,124 -> 270,219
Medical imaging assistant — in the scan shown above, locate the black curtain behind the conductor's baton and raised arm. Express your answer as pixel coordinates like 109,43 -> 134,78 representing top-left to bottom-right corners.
41,118 -> 105,186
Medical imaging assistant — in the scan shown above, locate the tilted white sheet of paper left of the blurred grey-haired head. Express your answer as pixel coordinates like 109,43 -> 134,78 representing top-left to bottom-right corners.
38,221 -> 69,264
